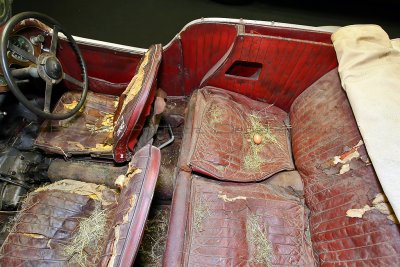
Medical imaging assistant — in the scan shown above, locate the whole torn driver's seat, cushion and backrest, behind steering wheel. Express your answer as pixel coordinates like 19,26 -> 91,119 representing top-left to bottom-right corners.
35,45 -> 162,162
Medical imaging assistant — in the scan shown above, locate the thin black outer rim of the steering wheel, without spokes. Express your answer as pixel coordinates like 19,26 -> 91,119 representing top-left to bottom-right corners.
0,12 -> 88,120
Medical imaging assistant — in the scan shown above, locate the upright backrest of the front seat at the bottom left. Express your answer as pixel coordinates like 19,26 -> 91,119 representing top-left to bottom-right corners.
100,145 -> 161,267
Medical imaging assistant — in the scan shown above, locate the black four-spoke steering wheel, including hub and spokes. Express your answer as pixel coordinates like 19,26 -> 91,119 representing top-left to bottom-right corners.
0,12 -> 88,120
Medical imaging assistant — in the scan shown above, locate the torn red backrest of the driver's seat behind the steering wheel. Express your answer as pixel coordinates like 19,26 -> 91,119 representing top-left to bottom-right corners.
113,44 -> 162,162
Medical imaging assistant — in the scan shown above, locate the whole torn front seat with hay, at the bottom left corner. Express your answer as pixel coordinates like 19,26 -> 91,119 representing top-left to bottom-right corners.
0,145 -> 160,266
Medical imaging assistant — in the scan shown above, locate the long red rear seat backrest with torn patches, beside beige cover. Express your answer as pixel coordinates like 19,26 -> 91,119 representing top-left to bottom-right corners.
290,69 -> 400,266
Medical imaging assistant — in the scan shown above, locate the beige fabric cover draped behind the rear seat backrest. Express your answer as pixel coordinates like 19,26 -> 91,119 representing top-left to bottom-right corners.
332,25 -> 400,218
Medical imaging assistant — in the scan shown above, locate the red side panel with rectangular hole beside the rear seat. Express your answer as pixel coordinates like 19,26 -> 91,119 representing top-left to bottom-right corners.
201,31 -> 337,111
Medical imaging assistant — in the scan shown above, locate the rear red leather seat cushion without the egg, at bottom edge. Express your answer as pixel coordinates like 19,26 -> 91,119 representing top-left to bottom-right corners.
164,175 -> 314,266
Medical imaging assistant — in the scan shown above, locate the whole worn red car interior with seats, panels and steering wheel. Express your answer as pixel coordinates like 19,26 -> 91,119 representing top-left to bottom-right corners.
0,6 -> 400,266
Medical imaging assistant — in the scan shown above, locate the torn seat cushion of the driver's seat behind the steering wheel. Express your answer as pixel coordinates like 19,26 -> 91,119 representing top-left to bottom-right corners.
35,92 -> 118,156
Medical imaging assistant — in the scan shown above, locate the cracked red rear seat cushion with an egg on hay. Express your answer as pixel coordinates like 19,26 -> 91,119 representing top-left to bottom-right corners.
186,87 -> 294,182
